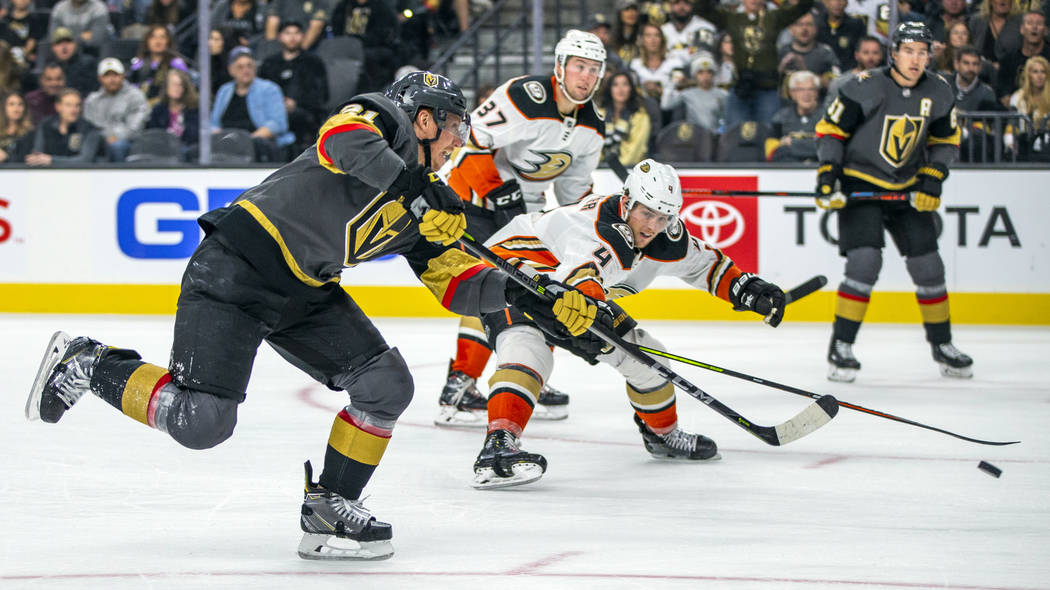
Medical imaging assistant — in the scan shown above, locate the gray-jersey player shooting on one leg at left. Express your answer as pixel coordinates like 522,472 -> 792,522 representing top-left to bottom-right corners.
25,72 -> 595,560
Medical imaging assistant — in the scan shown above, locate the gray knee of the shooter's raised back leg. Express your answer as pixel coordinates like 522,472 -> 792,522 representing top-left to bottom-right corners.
165,389 -> 237,450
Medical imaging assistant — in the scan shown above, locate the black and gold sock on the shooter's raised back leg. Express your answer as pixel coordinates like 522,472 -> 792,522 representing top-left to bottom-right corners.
91,349 -> 171,428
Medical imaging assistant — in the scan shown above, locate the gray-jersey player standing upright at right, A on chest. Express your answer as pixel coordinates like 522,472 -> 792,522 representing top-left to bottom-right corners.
817,22 -> 973,382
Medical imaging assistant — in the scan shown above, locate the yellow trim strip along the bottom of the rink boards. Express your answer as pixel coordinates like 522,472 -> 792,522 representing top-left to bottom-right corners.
0,279 -> 1050,325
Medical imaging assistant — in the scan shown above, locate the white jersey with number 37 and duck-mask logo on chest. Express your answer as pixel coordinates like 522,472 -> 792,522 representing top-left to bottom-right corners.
448,76 -> 605,211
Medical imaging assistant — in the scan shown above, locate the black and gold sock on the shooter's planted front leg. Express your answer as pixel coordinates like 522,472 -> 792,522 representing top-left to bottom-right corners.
318,405 -> 394,500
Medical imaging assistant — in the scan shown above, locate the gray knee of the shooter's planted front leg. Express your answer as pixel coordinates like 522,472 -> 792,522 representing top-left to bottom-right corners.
335,349 -> 415,420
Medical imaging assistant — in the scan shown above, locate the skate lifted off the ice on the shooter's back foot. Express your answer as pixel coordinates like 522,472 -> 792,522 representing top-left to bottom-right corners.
25,331 -> 106,424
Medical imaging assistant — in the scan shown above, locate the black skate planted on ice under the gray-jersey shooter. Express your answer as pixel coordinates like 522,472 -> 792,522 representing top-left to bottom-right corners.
299,461 -> 394,560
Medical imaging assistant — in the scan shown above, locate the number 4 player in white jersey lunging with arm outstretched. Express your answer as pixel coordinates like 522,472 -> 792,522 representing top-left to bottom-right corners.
474,160 -> 784,489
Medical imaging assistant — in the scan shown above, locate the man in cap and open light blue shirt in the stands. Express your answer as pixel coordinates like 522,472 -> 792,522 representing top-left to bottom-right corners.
211,47 -> 295,162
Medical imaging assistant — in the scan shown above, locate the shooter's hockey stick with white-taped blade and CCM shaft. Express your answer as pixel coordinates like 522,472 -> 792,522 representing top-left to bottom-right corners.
460,233 -> 839,446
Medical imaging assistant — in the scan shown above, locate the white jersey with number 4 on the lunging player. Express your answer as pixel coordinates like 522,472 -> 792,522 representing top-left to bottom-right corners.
485,194 -> 740,301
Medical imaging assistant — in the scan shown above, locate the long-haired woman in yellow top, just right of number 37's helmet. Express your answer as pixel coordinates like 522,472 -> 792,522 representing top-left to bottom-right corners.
595,71 -> 653,168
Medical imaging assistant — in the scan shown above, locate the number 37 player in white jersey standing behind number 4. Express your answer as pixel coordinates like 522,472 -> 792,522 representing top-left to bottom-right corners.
435,30 -> 606,426
